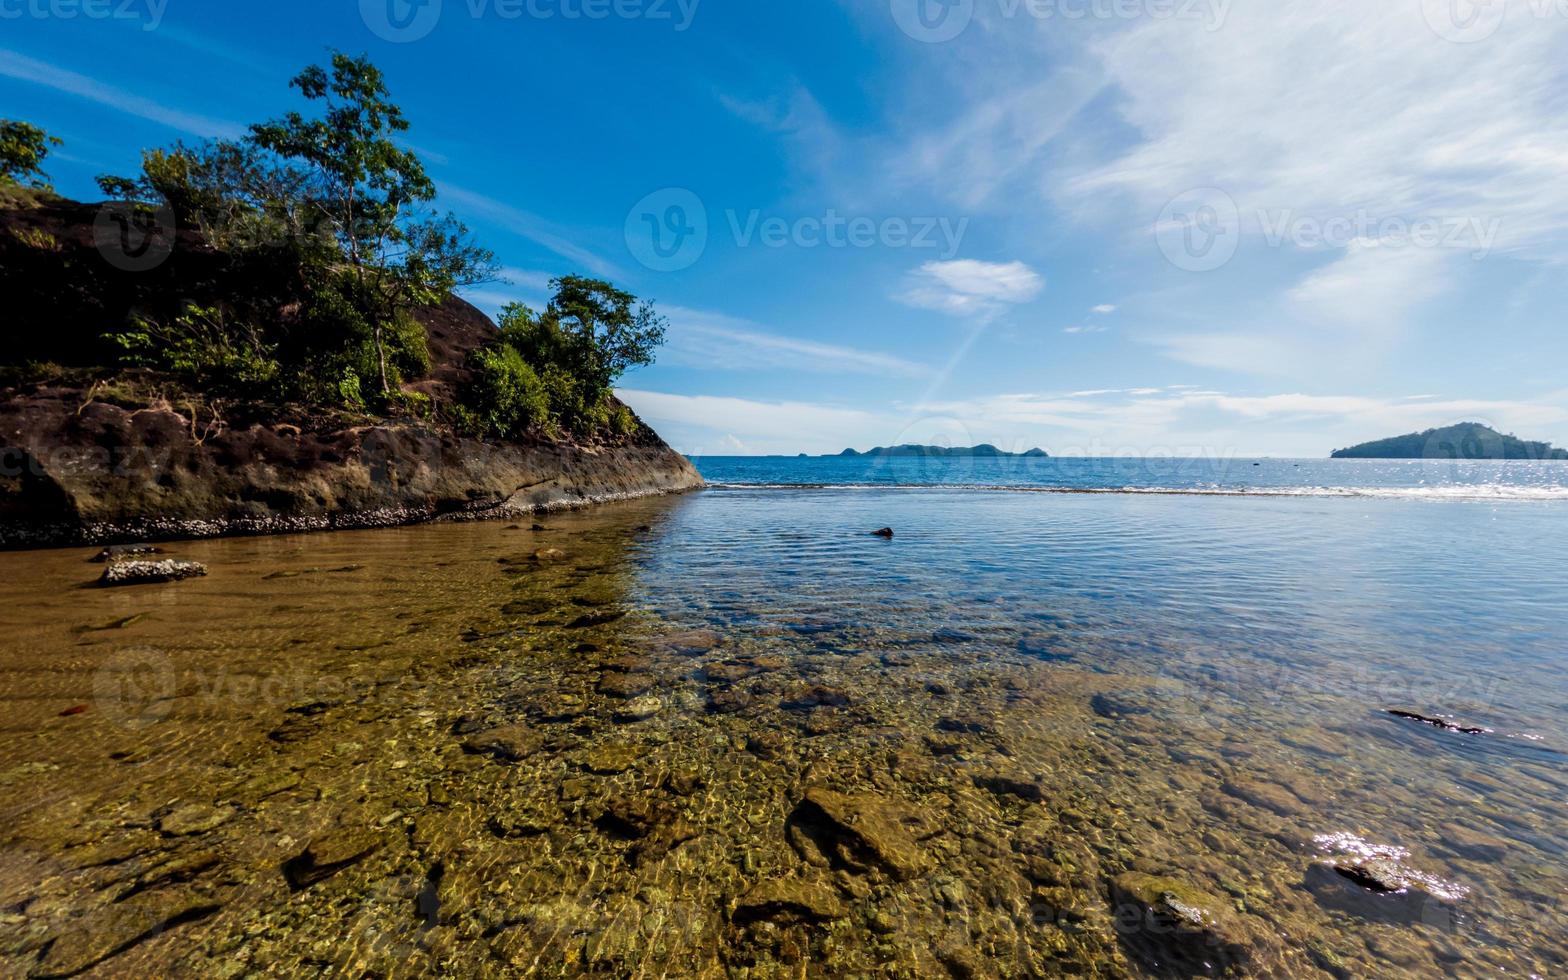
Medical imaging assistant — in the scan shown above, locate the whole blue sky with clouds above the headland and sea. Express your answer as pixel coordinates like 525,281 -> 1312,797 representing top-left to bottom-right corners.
0,0 -> 1568,455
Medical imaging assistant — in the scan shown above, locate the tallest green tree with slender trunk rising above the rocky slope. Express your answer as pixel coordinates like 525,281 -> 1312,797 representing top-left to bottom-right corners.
251,52 -> 495,400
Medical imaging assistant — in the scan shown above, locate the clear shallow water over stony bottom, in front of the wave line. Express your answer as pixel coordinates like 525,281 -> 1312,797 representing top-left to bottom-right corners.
0,491 -> 1568,977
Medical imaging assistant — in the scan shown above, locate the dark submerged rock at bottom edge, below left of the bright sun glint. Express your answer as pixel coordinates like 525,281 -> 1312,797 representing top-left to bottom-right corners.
1110,872 -> 1253,977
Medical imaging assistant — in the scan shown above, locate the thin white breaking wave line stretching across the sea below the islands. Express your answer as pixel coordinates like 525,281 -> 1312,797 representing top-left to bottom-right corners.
709,481 -> 1568,503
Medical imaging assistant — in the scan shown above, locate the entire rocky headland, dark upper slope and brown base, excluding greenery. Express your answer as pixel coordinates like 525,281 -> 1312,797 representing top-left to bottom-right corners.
0,194 -> 702,547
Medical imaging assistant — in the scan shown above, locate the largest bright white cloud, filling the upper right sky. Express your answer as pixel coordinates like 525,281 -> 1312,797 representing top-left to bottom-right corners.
1060,0 -> 1568,260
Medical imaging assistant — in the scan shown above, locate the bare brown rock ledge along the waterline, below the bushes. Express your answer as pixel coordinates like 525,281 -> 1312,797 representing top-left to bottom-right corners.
0,387 -> 702,547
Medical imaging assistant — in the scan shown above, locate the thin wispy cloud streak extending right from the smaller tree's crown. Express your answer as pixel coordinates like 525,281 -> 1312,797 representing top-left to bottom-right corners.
663,306 -> 931,378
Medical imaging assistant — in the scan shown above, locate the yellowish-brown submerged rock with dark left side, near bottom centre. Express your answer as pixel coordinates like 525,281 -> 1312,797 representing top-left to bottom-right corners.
790,787 -> 935,881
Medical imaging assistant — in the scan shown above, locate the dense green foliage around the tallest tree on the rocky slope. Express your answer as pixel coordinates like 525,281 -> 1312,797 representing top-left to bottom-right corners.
79,53 -> 494,411
